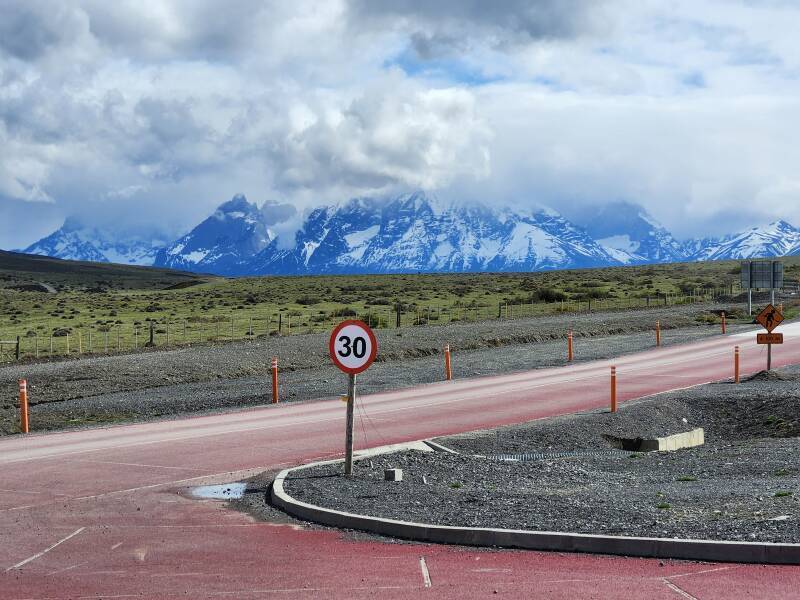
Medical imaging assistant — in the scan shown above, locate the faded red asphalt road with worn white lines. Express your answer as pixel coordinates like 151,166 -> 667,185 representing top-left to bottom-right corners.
0,324 -> 800,600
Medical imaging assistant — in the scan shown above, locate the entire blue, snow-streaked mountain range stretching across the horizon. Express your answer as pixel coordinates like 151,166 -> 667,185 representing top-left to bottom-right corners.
17,191 -> 800,276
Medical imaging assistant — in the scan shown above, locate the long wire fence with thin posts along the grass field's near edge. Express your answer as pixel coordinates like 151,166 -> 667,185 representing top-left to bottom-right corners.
0,288 -> 756,362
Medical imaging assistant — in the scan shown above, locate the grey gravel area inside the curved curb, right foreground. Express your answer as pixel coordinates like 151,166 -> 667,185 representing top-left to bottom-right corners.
287,367 -> 800,543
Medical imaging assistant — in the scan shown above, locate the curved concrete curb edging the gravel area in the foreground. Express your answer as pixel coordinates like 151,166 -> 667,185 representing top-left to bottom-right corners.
270,447 -> 800,565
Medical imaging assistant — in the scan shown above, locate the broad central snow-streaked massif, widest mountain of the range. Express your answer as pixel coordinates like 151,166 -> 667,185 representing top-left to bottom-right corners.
254,192 -> 616,274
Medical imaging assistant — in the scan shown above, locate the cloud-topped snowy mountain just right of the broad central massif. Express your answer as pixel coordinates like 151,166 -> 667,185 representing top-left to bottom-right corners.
582,202 -> 689,264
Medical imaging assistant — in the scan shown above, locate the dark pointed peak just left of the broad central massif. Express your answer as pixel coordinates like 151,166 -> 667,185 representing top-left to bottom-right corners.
155,194 -> 274,275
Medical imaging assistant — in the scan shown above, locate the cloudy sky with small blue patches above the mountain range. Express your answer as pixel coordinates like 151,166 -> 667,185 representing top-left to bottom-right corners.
0,0 -> 800,248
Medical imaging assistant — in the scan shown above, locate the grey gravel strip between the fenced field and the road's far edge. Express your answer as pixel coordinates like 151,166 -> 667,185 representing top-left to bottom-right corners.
0,304 -> 744,434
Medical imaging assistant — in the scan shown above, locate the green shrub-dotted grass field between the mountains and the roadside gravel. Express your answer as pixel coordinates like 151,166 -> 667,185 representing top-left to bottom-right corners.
0,252 -> 800,360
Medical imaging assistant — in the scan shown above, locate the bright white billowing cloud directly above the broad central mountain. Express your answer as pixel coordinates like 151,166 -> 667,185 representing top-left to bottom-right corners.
270,76 -> 489,192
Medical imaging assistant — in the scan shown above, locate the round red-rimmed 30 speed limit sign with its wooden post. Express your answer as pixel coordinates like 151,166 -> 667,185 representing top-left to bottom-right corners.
328,321 -> 378,475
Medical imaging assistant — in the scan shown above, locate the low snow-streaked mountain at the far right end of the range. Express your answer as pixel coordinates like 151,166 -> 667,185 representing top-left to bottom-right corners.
690,221 -> 800,261
